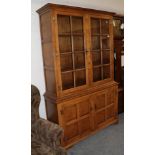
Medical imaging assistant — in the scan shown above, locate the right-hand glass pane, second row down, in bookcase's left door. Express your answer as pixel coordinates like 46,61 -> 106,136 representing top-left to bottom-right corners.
73,36 -> 84,51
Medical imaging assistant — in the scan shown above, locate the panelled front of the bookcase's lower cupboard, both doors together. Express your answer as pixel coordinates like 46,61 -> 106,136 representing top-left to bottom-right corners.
58,87 -> 118,147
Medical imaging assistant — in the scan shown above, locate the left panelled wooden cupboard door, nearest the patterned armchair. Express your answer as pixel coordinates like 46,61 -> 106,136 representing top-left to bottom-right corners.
60,96 -> 92,145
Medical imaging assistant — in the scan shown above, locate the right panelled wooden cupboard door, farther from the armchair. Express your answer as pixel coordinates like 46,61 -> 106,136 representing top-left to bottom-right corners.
90,87 -> 117,129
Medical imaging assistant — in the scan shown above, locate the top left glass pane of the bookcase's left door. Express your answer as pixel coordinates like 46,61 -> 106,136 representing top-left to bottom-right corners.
58,15 -> 71,34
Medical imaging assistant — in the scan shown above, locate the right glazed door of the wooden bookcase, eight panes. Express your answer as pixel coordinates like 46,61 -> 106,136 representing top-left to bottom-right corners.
90,17 -> 113,83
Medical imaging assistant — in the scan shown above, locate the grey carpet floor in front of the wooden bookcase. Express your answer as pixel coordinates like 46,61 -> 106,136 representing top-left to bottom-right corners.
67,114 -> 124,155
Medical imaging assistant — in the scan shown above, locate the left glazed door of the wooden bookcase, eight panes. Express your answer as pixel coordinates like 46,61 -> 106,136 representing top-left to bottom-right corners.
57,14 -> 87,92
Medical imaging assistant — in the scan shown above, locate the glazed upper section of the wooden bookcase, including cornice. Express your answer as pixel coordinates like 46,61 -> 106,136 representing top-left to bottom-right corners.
37,4 -> 117,97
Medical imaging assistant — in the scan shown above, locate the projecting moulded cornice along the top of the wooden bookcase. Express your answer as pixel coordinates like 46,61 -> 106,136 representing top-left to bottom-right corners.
37,3 -> 115,16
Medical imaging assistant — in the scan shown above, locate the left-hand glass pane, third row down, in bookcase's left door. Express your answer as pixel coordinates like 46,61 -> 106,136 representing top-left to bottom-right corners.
60,54 -> 73,71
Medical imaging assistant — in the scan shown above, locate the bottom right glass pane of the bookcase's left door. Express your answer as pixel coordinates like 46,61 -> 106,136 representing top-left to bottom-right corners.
75,70 -> 86,86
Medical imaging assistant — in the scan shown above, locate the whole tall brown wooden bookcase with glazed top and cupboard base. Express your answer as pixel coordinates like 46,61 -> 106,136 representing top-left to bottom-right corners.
37,4 -> 118,148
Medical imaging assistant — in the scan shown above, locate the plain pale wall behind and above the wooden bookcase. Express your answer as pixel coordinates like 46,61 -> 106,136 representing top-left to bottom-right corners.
31,0 -> 124,118
